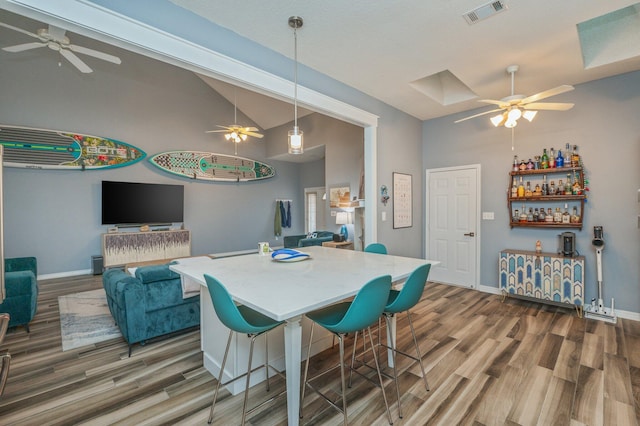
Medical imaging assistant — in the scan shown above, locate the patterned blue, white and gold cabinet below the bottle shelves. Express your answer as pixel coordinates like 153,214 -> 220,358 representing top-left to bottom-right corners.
498,250 -> 584,313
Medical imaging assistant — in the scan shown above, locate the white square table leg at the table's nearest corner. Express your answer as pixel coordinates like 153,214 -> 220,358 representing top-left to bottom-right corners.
284,316 -> 302,426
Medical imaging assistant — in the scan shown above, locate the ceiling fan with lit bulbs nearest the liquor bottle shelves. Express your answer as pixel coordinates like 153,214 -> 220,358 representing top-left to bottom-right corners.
454,65 -> 574,128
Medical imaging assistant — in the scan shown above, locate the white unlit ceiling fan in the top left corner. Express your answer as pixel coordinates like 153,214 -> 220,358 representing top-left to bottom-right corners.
0,22 -> 121,73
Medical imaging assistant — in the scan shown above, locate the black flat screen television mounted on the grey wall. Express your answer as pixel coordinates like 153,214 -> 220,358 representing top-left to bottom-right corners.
102,180 -> 184,225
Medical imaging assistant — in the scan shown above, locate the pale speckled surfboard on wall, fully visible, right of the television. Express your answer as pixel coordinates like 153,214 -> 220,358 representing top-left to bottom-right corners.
149,151 -> 276,182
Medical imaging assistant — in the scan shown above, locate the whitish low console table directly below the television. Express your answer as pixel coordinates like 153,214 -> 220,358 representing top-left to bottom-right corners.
102,229 -> 191,267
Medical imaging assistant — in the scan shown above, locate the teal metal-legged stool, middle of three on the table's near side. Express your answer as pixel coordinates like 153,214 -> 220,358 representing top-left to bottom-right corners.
300,275 -> 393,426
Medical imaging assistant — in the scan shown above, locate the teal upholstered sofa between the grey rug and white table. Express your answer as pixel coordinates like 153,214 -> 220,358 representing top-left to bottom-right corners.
102,264 -> 200,356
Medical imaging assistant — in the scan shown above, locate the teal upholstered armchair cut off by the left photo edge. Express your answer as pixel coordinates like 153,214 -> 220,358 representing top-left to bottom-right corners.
0,257 -> 38,333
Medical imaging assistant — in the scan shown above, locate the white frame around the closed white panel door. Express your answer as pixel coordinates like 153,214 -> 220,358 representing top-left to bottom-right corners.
424,164 -> 482,289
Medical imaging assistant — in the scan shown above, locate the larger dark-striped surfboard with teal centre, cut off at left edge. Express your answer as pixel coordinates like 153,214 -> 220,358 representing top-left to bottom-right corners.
0,125 -> 147,170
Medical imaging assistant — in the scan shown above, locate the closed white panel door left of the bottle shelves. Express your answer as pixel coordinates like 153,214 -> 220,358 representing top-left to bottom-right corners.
425,165 -> 480,288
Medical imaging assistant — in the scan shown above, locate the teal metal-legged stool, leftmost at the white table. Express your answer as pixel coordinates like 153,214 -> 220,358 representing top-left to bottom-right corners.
204,274 -> 286,425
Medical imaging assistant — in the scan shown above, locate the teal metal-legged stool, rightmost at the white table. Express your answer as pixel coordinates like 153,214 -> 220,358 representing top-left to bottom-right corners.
349,263 -> 431,418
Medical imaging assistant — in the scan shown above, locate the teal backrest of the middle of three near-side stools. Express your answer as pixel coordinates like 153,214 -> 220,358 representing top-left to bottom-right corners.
331,275 -> 391,333
